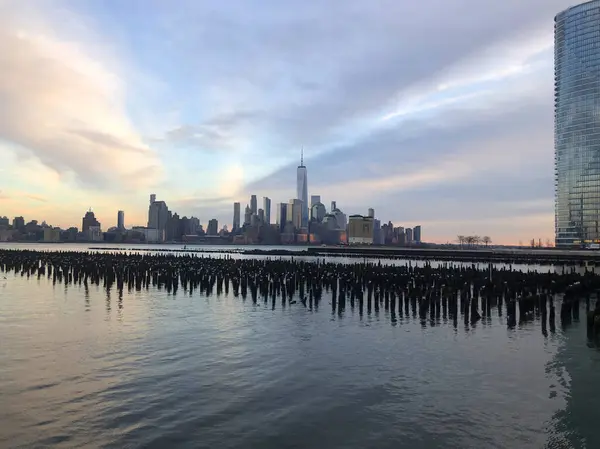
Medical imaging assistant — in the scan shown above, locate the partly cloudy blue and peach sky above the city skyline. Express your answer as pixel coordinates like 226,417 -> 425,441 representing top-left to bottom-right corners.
0,0 -> 576,244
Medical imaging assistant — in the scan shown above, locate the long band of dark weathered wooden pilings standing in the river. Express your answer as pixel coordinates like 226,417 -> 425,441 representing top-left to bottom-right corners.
0,250 -> 600,333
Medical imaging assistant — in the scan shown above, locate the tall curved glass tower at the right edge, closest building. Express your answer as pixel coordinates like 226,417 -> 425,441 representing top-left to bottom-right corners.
554,0 -> 600,247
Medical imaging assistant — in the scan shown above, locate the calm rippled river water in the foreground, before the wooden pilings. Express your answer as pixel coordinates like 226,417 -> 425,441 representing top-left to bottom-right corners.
0,244 -> 600,448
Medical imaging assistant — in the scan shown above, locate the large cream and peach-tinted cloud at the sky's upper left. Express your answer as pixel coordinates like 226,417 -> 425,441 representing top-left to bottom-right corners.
0,3 -> 161,188
